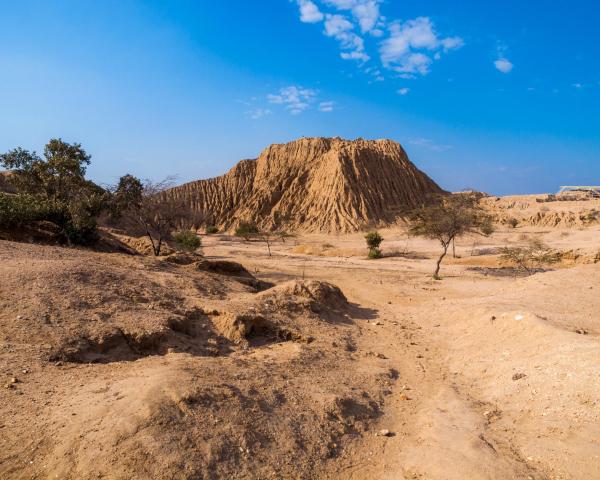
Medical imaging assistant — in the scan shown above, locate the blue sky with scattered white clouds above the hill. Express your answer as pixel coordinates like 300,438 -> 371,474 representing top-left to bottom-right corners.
0,0 -> 600,194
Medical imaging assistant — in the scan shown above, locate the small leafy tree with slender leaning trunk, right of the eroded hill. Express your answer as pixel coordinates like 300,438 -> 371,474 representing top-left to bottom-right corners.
409,192 -> 494,280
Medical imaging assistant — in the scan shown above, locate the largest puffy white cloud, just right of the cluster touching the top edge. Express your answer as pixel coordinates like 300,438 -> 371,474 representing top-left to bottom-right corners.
379,17 -> 464,77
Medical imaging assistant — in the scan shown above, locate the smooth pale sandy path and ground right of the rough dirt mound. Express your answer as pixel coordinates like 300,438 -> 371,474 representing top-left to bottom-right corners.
206,227 -> 600,480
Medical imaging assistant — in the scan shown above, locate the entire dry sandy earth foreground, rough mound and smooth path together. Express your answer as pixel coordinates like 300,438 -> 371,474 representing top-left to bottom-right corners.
0,223 -> 600,480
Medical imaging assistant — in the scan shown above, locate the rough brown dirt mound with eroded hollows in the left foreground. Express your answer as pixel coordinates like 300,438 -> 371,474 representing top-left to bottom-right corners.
0,241 -> 393,479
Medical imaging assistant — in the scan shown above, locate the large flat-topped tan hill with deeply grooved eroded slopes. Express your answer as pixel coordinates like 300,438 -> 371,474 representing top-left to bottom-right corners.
166,138 -> 442,232
